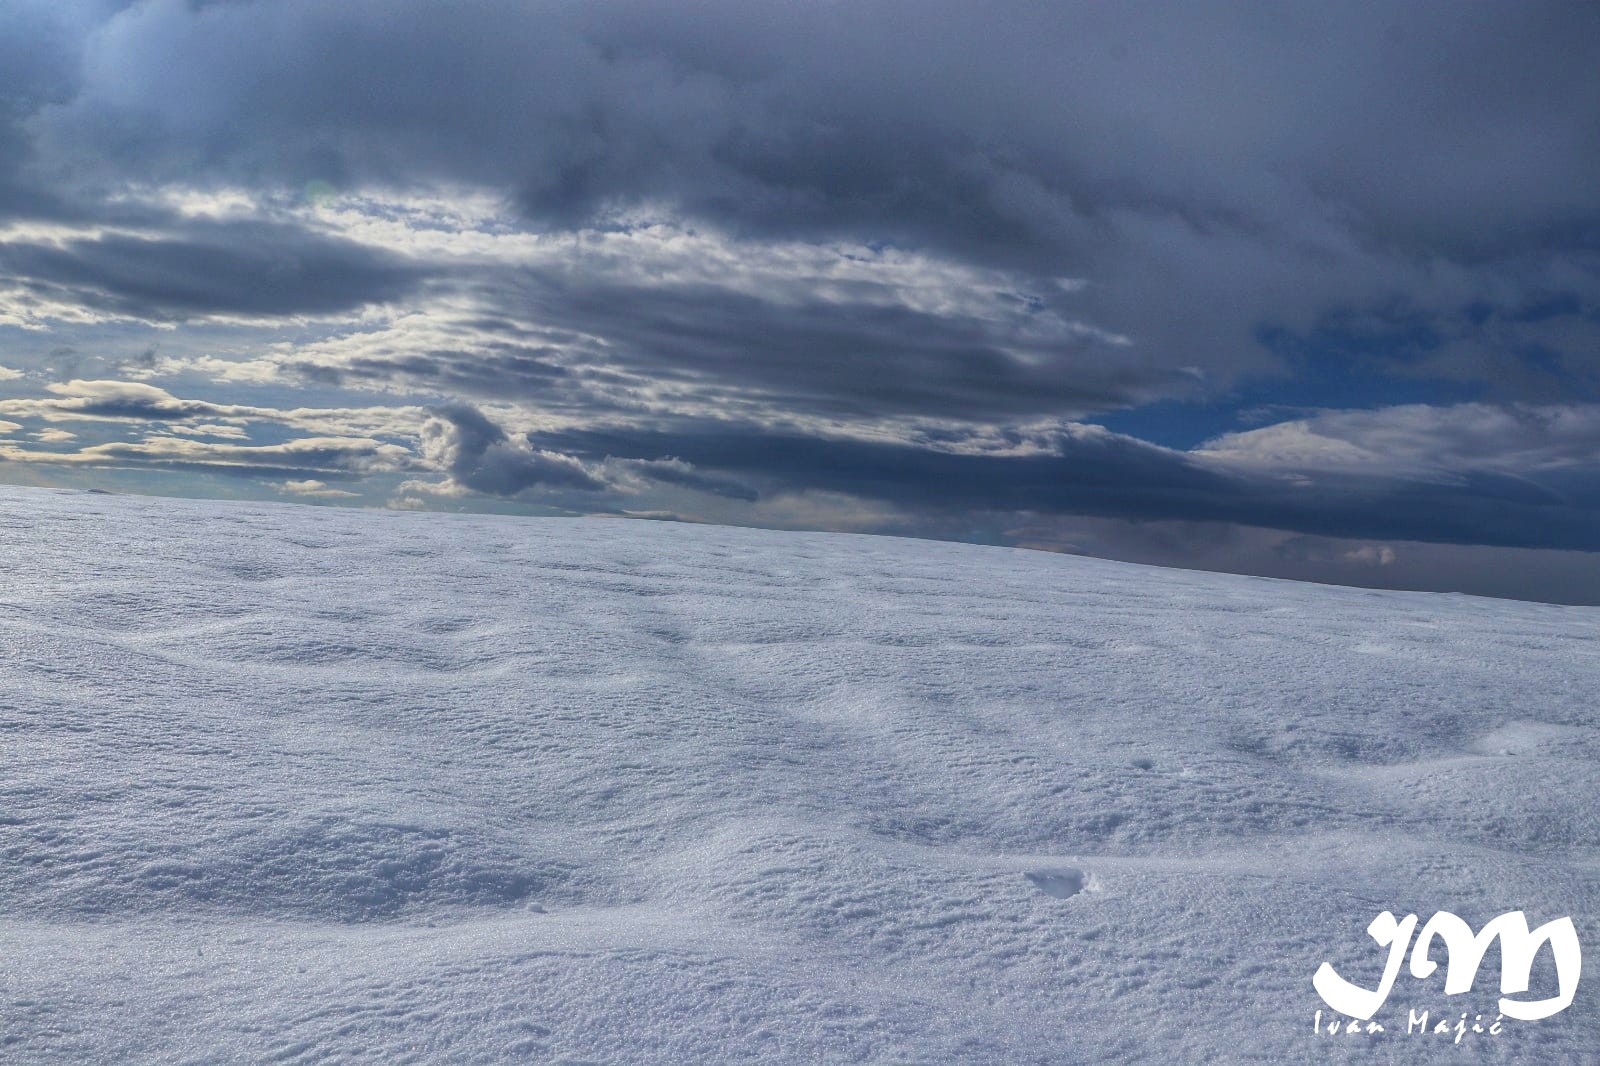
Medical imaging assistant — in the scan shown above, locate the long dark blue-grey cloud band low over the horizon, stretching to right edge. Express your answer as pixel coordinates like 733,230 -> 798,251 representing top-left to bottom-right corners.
533,412 -> 1600,551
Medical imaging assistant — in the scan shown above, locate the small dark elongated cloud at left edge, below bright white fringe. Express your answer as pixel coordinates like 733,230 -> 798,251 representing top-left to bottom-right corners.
0,222 -> 422,320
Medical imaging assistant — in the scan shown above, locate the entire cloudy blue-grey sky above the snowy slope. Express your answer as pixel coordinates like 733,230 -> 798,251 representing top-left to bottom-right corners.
0,0 -> 1600,603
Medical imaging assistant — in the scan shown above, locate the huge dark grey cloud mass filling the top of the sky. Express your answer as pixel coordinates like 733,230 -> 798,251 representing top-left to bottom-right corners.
34,0 -> 1600,389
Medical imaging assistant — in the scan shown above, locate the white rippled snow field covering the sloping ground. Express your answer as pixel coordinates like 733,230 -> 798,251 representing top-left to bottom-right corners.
0,488 -> 1600,1063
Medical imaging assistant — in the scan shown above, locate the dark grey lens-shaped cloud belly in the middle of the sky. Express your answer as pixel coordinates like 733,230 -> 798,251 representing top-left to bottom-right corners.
280,256 -> 1177,421
